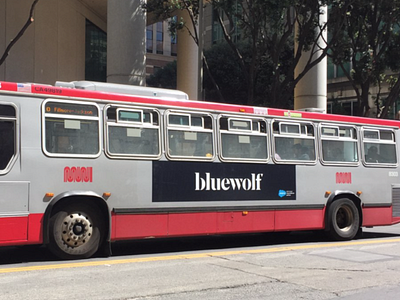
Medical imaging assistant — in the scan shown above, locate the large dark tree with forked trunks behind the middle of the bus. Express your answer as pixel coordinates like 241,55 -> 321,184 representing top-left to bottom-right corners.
146,0 -> 353,107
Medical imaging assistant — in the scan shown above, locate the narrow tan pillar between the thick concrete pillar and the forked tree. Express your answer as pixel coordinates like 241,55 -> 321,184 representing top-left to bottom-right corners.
177,10 -> 200,100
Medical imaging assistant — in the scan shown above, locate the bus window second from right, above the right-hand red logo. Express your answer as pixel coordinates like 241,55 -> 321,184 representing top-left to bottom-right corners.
320,124 -> 359,164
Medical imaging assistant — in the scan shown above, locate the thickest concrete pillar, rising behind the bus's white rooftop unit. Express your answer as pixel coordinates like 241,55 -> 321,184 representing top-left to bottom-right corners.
107,0 -> 146,86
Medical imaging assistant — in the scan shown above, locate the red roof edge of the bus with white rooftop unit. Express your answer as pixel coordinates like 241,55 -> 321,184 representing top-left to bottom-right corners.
0,81 -> 400,127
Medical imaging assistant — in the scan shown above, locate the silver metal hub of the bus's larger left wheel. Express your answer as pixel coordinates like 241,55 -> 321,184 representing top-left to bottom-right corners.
62,213 -> 93,247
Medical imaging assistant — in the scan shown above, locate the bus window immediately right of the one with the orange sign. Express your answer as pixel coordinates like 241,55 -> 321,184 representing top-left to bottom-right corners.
106,106 -> 161,159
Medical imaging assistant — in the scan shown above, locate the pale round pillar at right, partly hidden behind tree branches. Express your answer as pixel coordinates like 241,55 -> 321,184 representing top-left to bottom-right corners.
294,6 -> 328,113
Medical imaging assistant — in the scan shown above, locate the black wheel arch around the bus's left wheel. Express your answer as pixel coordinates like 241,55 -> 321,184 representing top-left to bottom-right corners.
43,195 -> 111,244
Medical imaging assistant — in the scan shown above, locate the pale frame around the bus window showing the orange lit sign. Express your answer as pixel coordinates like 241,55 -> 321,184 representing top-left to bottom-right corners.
42,98 -> 102,158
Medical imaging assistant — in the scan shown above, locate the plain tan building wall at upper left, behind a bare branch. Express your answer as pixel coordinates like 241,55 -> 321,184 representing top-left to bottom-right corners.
0,0 -> 103,84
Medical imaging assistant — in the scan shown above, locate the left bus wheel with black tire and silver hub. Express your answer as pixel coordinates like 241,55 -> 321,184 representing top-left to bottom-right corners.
49,203 -> 104,259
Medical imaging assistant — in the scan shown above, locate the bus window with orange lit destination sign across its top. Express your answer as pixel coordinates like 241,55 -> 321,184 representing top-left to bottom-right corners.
43,100 -> 100,157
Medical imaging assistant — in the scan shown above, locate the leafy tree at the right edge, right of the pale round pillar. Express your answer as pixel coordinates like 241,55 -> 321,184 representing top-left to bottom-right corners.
330,0 -> 400,118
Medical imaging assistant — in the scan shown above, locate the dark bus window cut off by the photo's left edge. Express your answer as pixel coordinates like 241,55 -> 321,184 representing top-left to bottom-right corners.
0,105 -> 16,174
